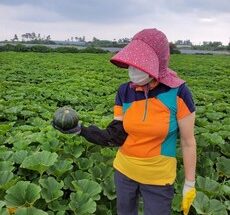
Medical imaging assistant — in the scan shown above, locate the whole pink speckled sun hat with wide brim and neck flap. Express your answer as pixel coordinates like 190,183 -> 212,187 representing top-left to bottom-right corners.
110,28 -> 185,88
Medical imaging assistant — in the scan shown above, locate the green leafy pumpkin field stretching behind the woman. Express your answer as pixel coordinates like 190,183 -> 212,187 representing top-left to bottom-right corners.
0,52 -> 230,215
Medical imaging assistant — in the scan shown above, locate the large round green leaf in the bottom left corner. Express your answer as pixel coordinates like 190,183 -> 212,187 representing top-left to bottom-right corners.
5,181 -> 41,207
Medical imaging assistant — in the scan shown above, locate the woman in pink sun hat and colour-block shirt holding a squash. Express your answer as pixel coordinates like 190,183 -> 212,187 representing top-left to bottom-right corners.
53,29 -> 196,215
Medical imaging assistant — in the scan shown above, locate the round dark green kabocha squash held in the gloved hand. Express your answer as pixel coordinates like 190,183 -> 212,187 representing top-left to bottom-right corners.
53,106 -> 78,130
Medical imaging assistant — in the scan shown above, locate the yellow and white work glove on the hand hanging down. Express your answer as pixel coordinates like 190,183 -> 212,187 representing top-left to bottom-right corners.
182,180 -> 196,215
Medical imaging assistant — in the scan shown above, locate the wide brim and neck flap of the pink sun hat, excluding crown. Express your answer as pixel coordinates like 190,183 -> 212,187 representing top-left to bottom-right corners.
110,40 -> 185,88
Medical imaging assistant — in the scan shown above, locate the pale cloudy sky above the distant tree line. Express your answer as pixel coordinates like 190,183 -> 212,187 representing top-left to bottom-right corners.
0,0 -> 230,44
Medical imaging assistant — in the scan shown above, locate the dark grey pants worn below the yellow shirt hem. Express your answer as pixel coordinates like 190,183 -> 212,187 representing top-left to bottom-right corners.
115,170 -> 174,215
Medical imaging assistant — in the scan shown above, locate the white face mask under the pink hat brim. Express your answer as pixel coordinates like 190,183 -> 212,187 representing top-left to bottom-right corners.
128,66 -> 153,86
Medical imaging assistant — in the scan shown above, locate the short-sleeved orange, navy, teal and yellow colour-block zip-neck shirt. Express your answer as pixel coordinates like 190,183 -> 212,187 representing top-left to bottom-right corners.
113,83 -> 195,185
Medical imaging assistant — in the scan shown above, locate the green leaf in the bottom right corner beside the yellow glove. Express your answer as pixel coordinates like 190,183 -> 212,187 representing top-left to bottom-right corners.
193,192 -> 227,215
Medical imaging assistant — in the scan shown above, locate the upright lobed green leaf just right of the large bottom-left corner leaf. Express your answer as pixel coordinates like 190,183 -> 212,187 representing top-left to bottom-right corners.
39,177 -> 64,203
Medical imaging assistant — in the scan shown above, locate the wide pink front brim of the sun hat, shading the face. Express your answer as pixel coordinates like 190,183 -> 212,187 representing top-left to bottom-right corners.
110,40 -> 159,79
